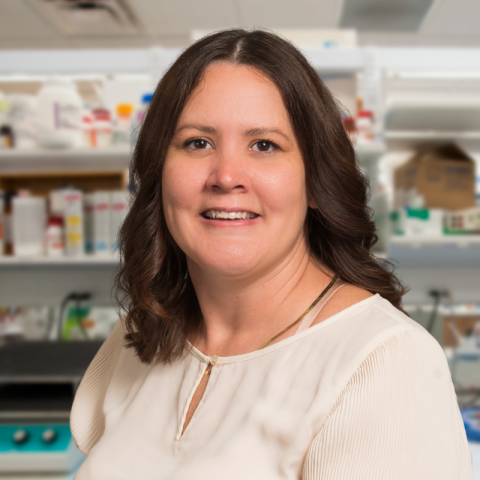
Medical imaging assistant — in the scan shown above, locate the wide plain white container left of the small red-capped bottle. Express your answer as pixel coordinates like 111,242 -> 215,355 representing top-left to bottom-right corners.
12,197 -> 46,257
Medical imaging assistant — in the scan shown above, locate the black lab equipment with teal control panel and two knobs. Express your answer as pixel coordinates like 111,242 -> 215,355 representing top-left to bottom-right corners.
0,341 -> 102,474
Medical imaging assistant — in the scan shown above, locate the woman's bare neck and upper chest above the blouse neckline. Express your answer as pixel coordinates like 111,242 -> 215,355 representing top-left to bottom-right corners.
188,239 -> 333,356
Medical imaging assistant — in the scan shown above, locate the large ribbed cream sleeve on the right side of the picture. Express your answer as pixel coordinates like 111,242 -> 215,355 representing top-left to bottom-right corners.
303,330 -> 472,480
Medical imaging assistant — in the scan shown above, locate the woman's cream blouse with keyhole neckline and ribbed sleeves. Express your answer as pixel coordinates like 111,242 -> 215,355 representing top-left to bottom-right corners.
71,294 -> 472,480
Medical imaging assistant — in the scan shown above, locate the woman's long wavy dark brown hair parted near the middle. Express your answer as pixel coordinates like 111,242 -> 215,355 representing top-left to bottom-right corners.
115,29 -> 405,363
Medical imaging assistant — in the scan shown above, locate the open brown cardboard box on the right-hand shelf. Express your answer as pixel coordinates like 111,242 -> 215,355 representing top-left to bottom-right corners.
394,144 -> 475,210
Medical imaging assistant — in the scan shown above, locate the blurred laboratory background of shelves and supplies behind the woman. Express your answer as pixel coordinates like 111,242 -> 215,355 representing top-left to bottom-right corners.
0,0 -> 480,480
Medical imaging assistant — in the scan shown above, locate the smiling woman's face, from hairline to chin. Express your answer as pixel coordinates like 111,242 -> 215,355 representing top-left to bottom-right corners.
162,63 -> 307,278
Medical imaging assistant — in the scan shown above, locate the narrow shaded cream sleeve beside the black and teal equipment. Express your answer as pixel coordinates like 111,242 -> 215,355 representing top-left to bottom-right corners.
70,320 -> 124,454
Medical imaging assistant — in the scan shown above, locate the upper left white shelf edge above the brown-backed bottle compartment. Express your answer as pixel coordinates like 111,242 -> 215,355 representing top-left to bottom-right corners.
0,147 -> 131,173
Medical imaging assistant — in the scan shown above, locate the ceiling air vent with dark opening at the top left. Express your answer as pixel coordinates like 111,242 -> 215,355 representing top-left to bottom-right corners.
30,0 -> 141,37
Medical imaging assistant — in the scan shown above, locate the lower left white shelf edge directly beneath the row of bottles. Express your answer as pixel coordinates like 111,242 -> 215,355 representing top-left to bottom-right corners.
0,255 -> 119,269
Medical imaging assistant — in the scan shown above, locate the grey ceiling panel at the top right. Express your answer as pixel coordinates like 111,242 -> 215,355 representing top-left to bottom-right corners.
340,0 -> 434,32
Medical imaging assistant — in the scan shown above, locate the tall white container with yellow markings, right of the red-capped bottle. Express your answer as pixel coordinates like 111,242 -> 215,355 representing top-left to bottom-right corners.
63,189 -> 85,257
